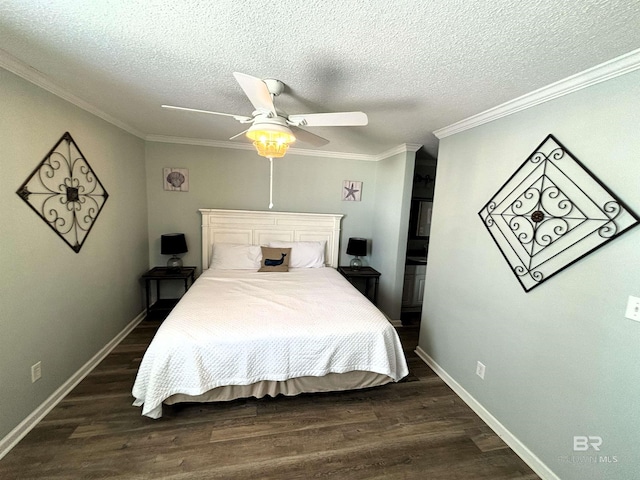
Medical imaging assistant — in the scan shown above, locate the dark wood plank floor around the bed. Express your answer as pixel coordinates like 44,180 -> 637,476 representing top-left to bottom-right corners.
0,321 -> 538,480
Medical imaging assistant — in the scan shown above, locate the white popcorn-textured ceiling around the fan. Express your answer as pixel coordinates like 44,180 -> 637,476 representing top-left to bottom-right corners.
0,0 -> 640,156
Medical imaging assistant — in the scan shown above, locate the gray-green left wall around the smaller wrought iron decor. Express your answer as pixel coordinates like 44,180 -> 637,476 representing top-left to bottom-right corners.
0,69 -> 149,438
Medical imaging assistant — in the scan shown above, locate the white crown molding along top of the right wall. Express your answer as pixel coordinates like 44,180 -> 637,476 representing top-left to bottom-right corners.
433,49 -> 640,138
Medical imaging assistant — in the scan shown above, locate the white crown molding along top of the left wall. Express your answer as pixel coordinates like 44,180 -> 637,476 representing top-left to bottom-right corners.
0,49 -> 144,139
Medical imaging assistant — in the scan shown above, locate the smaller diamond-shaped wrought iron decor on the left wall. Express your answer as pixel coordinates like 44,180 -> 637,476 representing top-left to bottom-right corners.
16,132 -> 109,253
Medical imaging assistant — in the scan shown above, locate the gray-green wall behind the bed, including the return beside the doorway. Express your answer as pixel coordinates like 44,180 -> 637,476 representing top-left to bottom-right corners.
146,142 -> 415,319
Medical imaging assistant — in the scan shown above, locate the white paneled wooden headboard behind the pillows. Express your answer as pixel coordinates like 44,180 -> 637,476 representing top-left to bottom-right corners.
200,208 -> 343,270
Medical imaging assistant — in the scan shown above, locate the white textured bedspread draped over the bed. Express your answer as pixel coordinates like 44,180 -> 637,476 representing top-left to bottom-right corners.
133,268 -> 408,418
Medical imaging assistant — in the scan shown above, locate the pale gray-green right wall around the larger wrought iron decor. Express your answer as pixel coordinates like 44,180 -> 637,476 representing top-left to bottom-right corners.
420,71 -> 640,480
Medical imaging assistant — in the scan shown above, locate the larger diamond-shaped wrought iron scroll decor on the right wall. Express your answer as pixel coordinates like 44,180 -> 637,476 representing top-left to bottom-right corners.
479,135 -> 639,292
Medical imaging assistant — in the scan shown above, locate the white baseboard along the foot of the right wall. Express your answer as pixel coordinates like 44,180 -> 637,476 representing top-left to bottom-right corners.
415,347 -> 560,480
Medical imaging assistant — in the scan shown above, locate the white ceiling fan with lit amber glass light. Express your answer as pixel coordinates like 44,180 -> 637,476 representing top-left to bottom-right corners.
162,72 -> 369,158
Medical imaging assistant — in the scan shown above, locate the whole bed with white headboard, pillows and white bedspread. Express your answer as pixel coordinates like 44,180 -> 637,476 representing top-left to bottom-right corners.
133,209 -> 408,418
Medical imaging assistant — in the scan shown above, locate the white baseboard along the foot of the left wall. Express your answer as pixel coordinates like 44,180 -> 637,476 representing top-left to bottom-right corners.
0,311 -> 146,459
